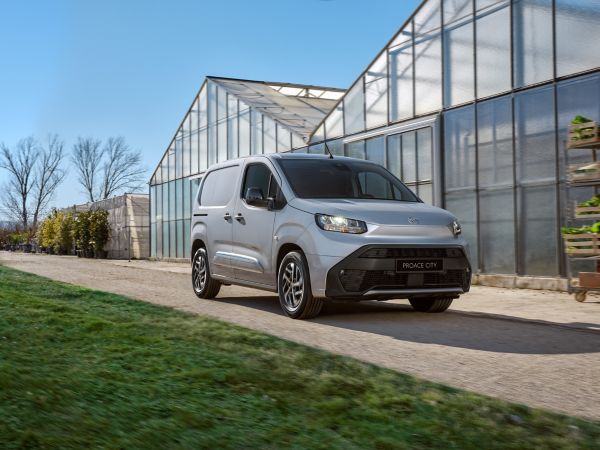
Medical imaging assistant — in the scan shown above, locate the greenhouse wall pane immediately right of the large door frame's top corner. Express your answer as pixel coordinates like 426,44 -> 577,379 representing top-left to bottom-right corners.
444,106 -> 475,189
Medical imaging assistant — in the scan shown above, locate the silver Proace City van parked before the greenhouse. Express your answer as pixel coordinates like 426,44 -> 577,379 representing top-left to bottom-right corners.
191,153 -> 471,319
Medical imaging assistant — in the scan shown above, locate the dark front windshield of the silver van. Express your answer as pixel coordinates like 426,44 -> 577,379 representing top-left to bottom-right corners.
277,158 -> 420,202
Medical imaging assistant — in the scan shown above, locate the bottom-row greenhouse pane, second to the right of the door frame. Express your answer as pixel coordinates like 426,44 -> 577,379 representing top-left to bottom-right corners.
479,189 -> 515,273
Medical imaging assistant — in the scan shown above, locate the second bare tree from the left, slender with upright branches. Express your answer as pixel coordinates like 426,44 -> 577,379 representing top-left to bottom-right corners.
33,134 -> 66,229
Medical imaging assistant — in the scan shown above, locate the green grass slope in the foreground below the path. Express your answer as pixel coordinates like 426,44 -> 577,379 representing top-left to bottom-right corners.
0,267 -> 600,450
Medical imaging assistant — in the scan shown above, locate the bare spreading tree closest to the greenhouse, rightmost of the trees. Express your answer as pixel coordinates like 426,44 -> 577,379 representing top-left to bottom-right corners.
100,137 -> 146,199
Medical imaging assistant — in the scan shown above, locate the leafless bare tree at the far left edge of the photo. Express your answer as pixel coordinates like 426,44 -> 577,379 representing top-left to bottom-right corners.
0,136 -> 40,229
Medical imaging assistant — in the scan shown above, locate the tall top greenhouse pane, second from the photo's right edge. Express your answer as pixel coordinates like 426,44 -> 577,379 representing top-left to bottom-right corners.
513,0 -> 553,87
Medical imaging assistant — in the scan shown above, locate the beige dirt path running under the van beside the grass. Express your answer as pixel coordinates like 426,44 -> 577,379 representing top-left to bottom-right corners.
0,252 -> 600,420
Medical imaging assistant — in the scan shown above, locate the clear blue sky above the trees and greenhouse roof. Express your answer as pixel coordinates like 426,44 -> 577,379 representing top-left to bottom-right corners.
0,0 -> 420,215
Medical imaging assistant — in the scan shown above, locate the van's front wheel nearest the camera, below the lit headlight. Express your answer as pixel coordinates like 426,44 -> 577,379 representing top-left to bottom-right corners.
277,251 -> 323,319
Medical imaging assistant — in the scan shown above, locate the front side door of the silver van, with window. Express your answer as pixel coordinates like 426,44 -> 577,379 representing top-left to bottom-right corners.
231,162 -> 282,287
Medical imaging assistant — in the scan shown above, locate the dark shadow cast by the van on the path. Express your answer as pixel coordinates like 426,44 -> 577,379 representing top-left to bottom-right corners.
215,296 -> 600,355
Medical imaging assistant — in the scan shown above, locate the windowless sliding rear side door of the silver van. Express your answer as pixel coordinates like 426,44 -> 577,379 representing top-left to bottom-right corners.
194,165 -> 240,278
